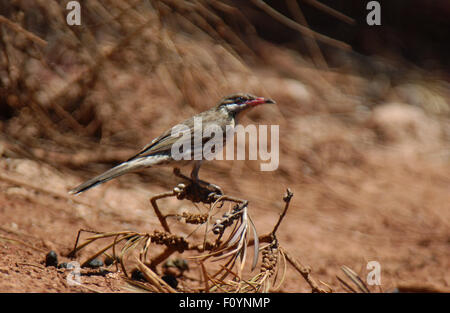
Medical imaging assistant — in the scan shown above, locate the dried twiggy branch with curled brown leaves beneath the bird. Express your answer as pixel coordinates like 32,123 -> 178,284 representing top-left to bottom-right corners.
69,182 -> 326,292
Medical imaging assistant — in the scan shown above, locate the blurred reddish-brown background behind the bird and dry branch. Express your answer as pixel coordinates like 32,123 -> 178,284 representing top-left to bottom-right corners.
0,0 -> 450,291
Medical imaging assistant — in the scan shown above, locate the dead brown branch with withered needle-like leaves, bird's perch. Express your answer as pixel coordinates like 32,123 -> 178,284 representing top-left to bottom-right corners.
70,182 -> 326,292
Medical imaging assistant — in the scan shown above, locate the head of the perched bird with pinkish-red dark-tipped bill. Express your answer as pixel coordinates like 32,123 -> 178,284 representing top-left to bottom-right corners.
217,93 -> 275,116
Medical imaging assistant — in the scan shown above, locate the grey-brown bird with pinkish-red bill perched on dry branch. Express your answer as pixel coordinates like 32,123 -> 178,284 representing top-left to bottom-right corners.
69,92 -> 276,194
